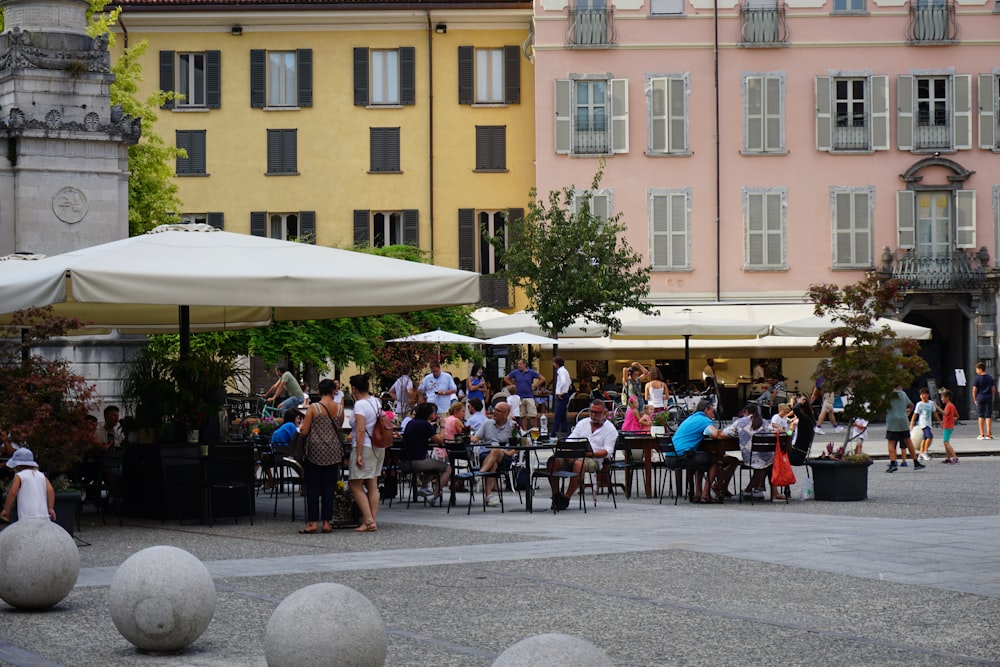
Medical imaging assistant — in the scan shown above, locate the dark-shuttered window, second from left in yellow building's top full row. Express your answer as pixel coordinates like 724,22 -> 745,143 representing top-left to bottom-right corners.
250,49 -> 312,109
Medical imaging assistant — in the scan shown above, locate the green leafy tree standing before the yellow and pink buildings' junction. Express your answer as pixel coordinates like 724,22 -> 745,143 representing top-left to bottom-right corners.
484,160 -> 652,338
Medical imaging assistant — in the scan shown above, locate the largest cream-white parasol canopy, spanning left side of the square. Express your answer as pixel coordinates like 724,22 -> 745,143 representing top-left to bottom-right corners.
0,225 -> 479,340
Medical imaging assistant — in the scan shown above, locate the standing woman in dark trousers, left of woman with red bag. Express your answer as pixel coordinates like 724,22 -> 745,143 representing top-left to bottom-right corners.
299,380 -> 344,535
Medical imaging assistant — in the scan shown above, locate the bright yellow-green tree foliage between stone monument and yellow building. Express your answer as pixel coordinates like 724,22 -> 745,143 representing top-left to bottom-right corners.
87,0 -> 186,236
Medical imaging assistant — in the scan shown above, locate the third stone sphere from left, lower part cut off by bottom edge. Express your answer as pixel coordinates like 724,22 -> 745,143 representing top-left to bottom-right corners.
264,583 -> 388,667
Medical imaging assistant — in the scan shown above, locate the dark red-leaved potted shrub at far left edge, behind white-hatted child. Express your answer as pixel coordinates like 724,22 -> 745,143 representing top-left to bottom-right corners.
0,308 -> 97,534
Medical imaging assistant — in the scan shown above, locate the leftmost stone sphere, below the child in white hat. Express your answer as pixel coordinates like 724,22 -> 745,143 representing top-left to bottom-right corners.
0,519 -> 80,609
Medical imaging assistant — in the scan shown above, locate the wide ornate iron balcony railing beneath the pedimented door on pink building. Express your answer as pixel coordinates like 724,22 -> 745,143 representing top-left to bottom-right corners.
882,250 -> 989,292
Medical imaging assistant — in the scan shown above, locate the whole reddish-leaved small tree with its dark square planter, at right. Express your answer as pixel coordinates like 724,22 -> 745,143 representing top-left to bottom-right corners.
806,273 -> 928,500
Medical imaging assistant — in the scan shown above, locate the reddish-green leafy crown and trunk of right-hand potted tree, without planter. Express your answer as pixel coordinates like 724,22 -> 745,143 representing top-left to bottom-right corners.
807,273 -> 928,444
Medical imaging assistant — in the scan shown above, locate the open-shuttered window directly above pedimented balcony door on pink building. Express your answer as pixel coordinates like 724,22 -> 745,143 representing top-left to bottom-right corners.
896,74 -> 972,152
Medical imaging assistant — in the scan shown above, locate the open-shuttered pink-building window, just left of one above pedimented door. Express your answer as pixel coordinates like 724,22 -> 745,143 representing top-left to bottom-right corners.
816,76 -> 889,152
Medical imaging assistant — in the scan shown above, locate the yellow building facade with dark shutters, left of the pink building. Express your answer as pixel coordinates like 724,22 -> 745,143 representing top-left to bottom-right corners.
118,0 -> 535,307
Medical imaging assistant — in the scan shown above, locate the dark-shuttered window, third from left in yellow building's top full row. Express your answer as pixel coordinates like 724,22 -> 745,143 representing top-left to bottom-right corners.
354,46 -> 416,106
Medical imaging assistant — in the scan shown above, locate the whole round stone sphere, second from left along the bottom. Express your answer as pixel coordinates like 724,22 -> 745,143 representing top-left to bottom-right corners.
108,546 -> 216,651
